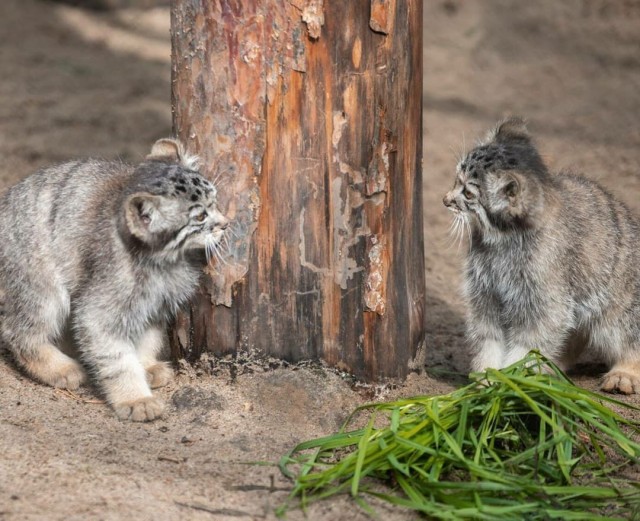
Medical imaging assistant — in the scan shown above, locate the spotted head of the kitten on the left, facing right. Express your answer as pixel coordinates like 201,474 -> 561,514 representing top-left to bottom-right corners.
124,140 -> 229,258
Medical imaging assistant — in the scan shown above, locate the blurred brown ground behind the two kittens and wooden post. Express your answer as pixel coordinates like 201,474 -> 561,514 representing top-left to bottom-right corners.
0,0 -> 640,371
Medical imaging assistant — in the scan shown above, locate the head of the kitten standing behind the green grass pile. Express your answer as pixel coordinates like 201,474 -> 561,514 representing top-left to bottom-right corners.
443,120 -> 546,234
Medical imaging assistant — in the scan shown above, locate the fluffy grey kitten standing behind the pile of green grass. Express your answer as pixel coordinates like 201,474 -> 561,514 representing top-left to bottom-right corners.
444,118 -> 640,394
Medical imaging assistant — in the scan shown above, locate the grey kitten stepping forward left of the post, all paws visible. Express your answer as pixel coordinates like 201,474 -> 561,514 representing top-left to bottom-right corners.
0,139 -> 228,421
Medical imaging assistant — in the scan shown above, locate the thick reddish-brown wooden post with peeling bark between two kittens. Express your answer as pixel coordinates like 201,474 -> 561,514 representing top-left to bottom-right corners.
170,0 -> 425,380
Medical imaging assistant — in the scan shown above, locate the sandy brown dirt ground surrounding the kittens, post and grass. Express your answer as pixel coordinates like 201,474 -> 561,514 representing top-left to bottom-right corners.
0,0 -> 640,521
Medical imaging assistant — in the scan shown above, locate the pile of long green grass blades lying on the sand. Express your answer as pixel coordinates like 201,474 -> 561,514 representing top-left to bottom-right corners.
278,352 -> 640,521
